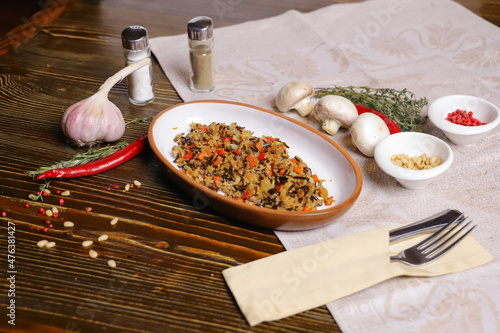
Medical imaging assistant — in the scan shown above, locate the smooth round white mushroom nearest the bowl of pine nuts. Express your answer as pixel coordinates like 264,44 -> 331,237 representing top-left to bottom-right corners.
351,112 -> 391,157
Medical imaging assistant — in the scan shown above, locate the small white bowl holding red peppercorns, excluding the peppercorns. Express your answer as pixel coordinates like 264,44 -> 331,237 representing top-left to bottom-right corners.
429,95 -> 500,146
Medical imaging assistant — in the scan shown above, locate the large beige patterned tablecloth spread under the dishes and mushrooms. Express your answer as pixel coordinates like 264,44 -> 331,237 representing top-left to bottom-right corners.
151,0 -> 500,333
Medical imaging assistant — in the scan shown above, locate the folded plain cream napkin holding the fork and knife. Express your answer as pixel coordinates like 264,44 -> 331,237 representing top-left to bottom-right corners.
222,227 -> 493,326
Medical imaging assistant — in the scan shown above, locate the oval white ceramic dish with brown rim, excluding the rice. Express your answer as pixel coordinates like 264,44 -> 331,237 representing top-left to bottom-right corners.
148,101 -> 363,230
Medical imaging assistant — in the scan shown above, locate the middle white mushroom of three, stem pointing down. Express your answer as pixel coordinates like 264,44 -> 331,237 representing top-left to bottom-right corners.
312,95 -> 358,135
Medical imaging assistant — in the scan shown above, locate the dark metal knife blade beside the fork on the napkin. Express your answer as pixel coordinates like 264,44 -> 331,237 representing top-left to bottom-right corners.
389,209 -> 462,242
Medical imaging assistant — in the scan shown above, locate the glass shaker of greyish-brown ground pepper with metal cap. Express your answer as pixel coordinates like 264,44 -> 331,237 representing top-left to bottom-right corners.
187,16 -> 215,92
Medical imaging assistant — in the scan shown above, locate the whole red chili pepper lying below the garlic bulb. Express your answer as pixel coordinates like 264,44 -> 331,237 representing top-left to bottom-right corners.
36,134 -> 147,179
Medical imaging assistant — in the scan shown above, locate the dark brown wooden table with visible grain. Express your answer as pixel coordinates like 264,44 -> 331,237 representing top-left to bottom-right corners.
0,0 -> 500,332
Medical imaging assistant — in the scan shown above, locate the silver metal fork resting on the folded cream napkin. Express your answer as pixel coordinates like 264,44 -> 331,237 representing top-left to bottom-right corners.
391,215 -> 476,266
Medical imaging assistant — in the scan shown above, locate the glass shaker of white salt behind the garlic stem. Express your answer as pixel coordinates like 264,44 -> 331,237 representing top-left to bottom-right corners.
122,25 -> 155,105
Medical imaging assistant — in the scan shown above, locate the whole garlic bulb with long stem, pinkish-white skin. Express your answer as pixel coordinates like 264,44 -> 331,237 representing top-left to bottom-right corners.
62,58 -> 151,147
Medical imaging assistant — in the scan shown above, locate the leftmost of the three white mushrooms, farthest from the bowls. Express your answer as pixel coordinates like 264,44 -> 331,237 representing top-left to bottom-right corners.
276,81 -> 314,117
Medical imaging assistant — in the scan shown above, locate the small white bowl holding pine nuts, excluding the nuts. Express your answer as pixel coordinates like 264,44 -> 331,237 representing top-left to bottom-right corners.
374,132 -> 453,190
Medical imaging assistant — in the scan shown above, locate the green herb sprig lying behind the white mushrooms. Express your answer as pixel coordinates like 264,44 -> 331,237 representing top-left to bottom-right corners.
316,86 -> 428,132
